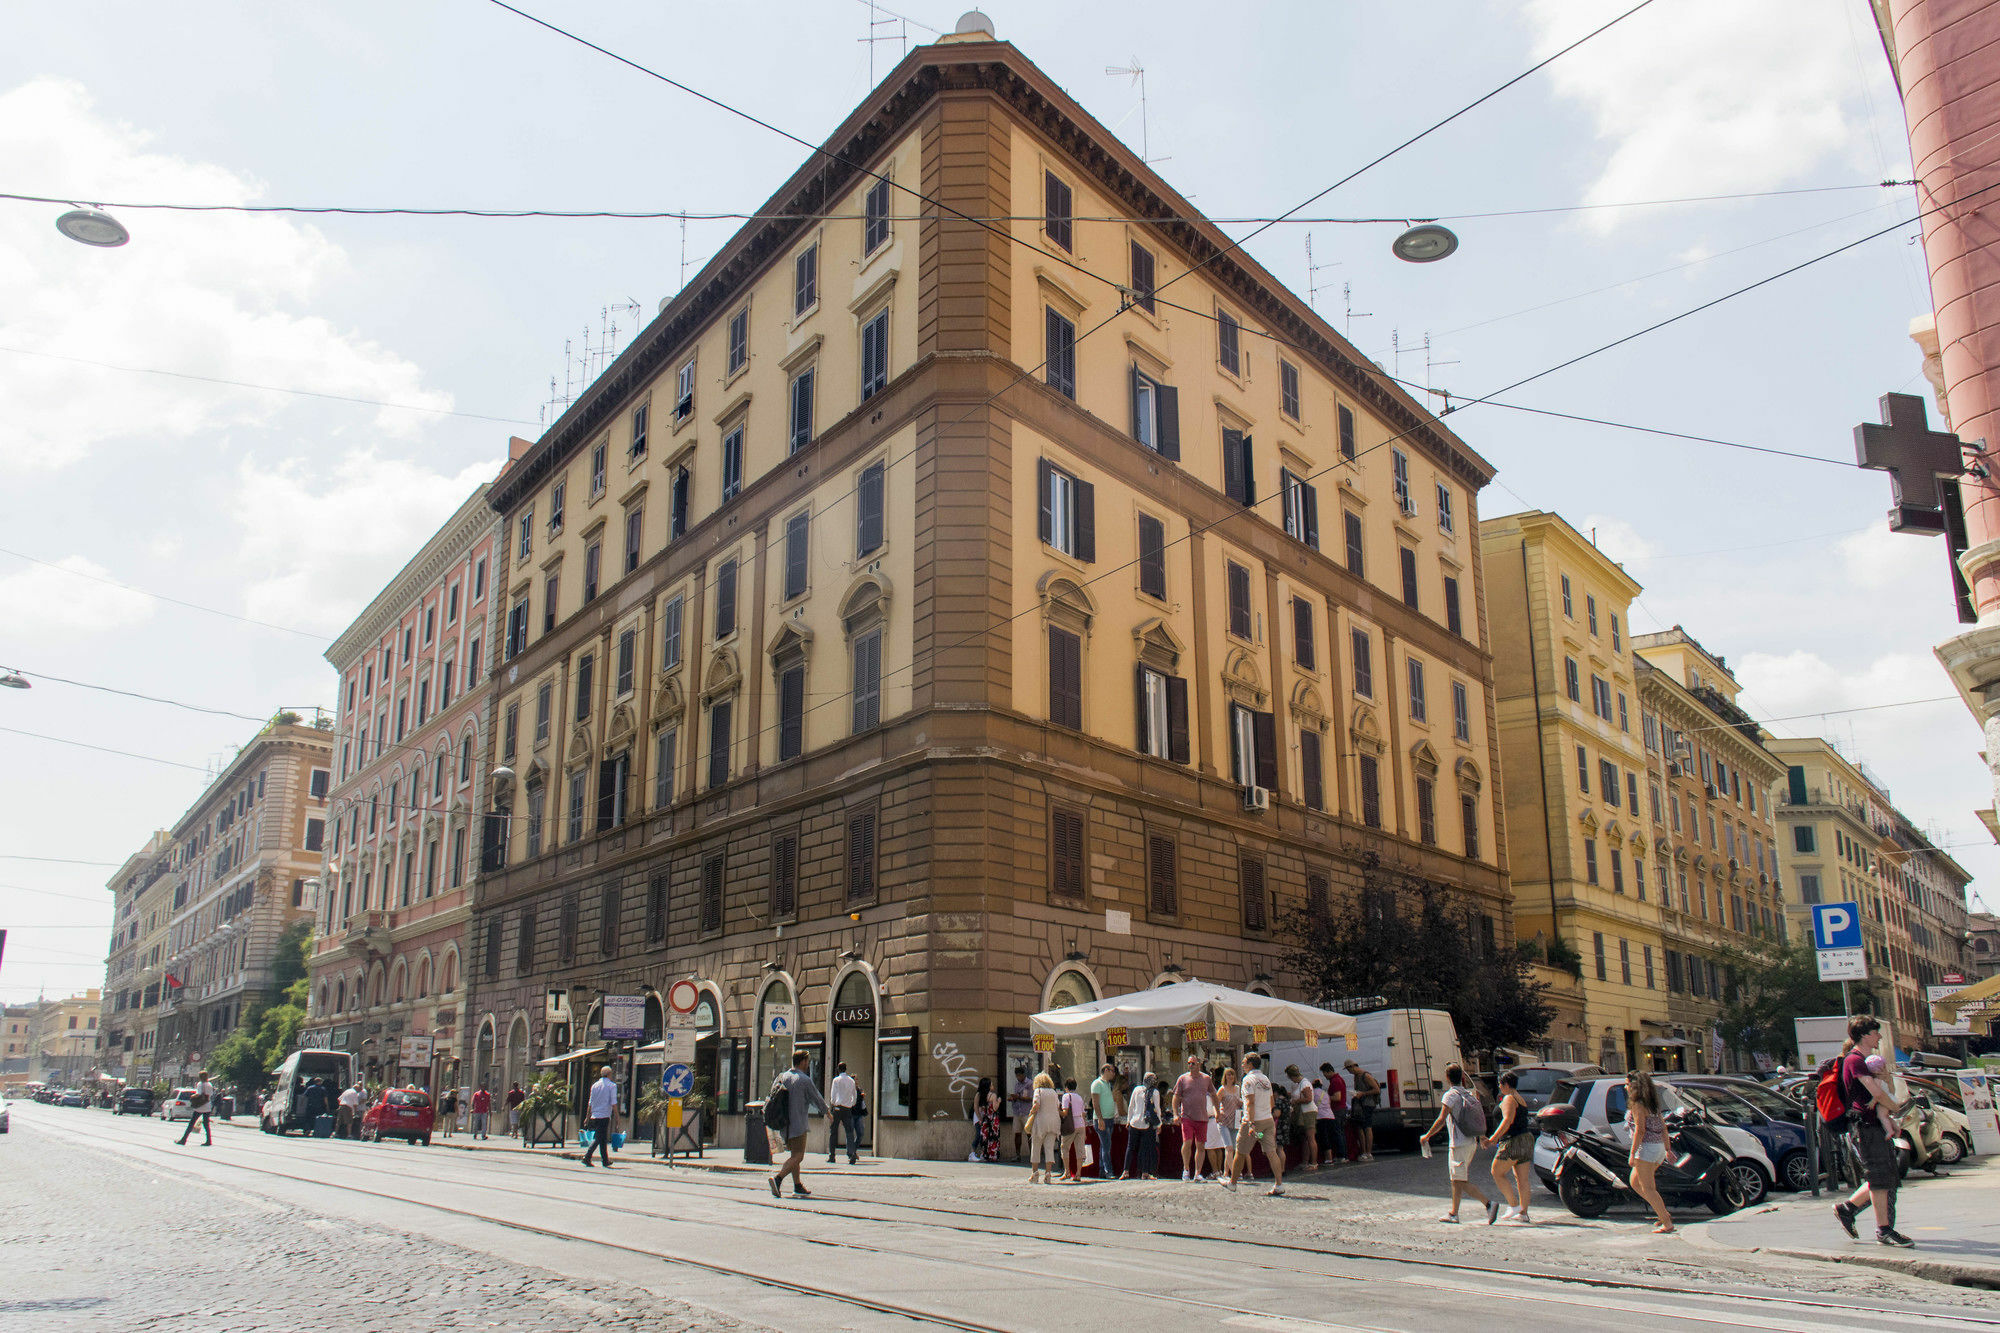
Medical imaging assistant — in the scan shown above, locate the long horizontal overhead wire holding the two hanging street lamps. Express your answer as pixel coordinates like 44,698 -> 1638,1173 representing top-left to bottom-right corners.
0,180 -> 1916,226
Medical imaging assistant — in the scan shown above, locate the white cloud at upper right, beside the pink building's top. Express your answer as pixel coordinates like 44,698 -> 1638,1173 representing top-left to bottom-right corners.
1526,0 -> 1908,232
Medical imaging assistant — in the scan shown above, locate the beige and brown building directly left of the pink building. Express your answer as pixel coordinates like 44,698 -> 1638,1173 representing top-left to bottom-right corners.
154,713 -> 332,1081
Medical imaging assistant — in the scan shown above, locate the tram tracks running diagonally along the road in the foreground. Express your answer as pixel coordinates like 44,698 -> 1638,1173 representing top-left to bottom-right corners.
35,1112 -> 2000,1329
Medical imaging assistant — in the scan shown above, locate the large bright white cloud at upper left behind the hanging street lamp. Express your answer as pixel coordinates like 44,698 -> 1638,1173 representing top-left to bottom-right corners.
0,78 -> 450,470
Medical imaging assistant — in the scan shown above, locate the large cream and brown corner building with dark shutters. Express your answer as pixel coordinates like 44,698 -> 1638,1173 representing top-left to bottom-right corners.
468,13 -> 1512,1155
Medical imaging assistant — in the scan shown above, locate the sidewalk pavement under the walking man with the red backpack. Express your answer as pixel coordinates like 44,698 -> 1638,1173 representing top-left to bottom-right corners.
1682,1157 -> 2000,1291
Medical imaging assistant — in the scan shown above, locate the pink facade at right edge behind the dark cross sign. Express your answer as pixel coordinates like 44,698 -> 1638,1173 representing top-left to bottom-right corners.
1874,0 -> 2000,837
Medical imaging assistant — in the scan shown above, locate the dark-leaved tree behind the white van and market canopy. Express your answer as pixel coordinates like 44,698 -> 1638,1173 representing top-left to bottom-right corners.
1286,867 -> 1556,1051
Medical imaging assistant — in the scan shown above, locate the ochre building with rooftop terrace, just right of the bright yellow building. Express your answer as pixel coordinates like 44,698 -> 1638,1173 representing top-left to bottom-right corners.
1632,624 -> 1790,1071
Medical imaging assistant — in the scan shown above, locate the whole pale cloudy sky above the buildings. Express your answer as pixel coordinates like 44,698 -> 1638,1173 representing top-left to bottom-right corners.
0,0 -> 2000,1001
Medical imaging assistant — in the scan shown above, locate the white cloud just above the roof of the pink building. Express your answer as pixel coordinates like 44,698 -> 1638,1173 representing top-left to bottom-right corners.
230,452 -> 498,632
